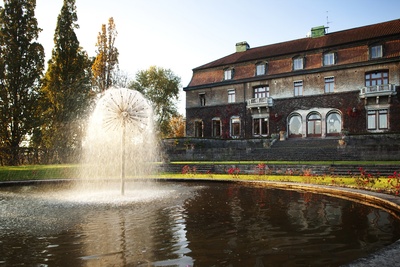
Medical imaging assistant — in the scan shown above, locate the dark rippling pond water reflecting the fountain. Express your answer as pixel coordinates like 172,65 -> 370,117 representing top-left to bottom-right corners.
0,182 -> 400,266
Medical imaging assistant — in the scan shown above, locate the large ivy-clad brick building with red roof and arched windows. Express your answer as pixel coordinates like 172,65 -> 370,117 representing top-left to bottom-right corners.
184,19 -> 400,138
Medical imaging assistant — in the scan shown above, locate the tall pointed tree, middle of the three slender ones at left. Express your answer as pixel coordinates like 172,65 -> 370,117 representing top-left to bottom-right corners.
35,0 -> 91,162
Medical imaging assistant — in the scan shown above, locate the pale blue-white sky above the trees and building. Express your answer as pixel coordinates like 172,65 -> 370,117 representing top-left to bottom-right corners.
0,0 -> 400,115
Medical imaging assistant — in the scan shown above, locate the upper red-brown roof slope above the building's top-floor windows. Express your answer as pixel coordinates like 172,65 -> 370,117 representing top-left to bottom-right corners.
193,19 -> 400,71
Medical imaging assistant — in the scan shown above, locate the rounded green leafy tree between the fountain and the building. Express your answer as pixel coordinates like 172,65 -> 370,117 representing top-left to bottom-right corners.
130,66 -> 181,138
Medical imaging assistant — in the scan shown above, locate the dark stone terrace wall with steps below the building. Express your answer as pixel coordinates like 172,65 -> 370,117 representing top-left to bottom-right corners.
163,134 -> 400,162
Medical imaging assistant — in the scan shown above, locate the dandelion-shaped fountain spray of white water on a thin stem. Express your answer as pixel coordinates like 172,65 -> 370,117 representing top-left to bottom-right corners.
80,88 -> 157,195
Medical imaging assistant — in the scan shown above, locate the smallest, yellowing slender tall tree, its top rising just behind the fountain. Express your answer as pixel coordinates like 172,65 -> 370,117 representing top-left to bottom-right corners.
92,17 -> 119,92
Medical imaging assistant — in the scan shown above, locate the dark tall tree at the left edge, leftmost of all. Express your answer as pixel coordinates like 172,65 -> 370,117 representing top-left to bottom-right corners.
0,0 -> 44,165
